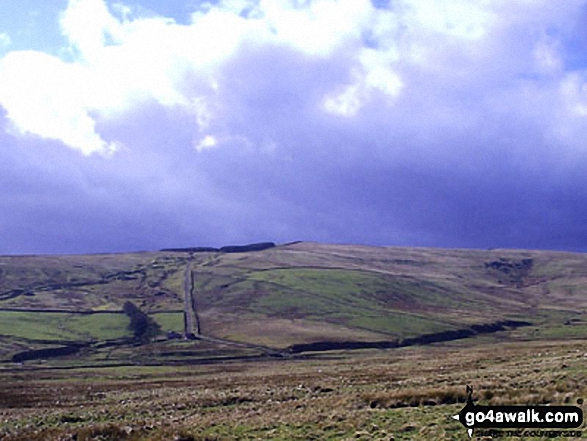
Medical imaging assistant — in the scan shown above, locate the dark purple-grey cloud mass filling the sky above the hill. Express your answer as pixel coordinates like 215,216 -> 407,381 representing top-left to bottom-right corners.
0,2 -> 587,253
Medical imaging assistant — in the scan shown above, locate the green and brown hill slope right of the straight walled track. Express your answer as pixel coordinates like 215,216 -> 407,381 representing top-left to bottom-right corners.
189,243 -> 587,342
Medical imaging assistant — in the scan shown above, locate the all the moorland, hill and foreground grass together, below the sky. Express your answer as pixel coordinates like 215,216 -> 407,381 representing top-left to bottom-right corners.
0,243 -> 587,441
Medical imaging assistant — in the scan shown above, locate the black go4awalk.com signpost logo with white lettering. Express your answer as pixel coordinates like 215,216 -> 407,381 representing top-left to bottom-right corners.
453,386 -> 583,438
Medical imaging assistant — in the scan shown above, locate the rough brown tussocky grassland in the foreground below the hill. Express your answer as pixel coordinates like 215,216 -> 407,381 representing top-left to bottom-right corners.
0,340 -> 587,440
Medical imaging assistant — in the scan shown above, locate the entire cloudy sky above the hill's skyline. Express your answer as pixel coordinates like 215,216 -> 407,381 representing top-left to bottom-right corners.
0,0 -> 587,254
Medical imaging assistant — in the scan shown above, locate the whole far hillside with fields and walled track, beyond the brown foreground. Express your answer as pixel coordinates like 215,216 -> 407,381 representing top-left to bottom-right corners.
0,242 -> 587,363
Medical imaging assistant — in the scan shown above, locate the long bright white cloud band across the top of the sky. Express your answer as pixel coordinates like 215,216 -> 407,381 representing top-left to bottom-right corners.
0,0 -> 584,154
